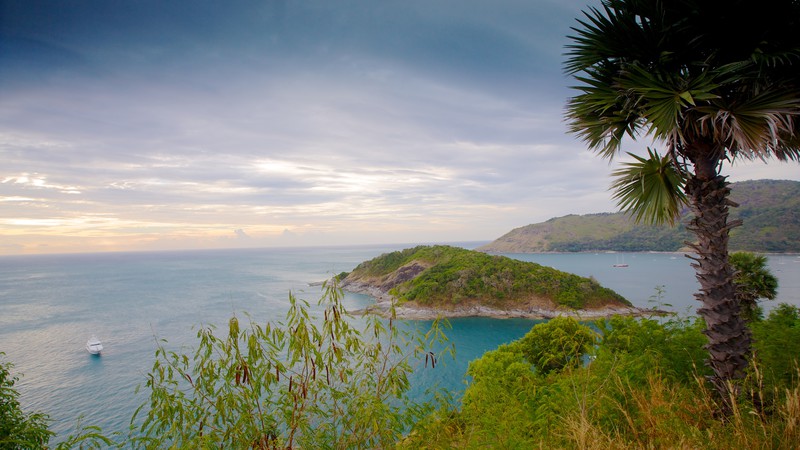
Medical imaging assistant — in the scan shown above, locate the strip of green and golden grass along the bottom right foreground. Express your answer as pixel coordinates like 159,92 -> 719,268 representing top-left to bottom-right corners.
398,364 -> 800,450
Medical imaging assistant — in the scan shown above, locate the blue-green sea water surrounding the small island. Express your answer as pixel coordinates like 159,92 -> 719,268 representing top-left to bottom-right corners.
0,244 -> 800,442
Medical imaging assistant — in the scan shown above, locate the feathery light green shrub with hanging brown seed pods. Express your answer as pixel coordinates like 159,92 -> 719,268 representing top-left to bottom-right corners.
131,285 -> 443,449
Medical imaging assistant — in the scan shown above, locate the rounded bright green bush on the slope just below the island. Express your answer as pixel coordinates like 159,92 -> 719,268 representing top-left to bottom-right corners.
519,317 -> 595,374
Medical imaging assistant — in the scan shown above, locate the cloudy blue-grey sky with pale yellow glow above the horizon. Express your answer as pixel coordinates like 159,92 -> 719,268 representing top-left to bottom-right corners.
0,0 -> 800,255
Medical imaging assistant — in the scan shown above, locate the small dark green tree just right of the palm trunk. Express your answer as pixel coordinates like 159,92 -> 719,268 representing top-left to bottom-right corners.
730,252 -> 778,322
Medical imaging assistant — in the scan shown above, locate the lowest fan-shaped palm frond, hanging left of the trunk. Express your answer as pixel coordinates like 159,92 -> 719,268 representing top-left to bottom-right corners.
611,148 -> 687,226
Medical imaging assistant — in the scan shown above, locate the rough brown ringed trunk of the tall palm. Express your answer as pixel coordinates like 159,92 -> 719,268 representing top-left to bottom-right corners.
686,175 -> 751,415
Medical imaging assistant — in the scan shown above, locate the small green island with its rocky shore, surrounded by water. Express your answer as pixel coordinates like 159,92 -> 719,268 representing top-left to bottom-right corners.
338,245 -> 660,320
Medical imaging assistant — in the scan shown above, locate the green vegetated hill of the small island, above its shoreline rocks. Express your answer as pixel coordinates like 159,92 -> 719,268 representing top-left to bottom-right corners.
343,245 -> 630,309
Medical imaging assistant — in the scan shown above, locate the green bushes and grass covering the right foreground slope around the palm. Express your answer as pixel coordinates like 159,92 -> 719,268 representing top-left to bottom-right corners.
399,306 -> 800,449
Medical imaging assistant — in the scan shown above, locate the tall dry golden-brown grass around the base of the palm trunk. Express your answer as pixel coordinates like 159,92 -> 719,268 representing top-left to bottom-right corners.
551,368 -> 800,449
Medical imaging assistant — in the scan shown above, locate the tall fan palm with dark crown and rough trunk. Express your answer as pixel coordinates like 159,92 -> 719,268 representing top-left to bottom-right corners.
564,0 -> 800,413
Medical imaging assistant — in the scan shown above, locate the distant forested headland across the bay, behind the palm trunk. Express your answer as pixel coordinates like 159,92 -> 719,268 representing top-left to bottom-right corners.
477,180 -> 800,253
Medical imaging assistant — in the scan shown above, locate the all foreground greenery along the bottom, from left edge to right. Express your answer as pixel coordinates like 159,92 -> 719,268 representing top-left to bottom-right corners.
0,296 -> 800,449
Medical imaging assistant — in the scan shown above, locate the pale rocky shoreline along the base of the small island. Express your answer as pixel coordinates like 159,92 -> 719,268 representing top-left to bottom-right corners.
340,281 -> 670,320
